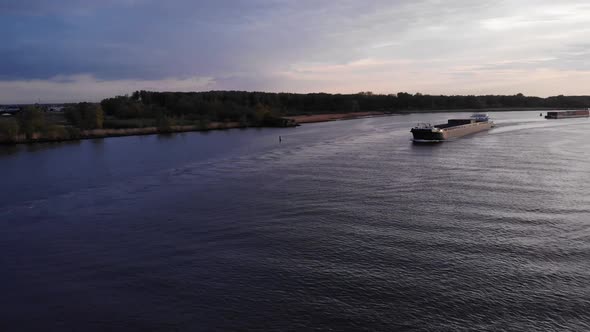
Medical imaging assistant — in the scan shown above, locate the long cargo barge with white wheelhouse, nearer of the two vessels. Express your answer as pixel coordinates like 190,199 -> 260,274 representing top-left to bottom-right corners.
410,114 -> 494,142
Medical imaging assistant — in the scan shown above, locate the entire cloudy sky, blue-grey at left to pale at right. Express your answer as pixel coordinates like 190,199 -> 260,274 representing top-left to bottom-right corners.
0,0 -> 590,103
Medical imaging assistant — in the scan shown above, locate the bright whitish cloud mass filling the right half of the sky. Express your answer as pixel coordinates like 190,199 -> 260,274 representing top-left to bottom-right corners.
252,0 -> 590,96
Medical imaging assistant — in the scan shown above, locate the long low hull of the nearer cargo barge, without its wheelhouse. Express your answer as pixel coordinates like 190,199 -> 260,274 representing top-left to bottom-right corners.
411,121 -> 494,143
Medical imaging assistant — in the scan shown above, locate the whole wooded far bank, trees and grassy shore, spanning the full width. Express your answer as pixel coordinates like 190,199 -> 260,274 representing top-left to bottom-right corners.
0,91 -> 590,142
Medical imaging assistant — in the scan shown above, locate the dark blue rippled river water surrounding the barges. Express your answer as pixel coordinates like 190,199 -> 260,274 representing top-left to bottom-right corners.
0,112 -> 590,331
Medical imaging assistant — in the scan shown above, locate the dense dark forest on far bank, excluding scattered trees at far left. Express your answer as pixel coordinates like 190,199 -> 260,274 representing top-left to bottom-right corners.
101,91 -> 590,124
